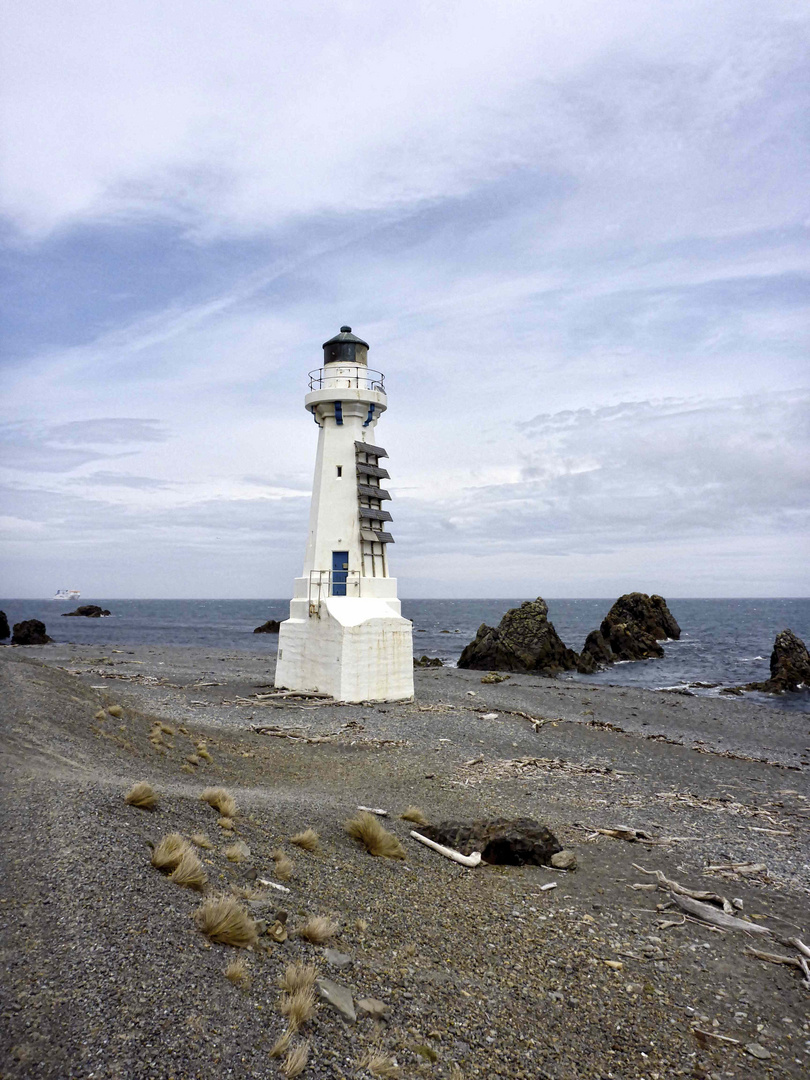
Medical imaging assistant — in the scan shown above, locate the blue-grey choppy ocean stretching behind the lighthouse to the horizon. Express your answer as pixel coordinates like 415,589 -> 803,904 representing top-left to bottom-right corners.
0,596 -> 810,711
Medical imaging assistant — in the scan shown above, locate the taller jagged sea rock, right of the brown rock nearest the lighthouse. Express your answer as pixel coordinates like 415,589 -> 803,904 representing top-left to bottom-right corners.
577,593 -> 680,673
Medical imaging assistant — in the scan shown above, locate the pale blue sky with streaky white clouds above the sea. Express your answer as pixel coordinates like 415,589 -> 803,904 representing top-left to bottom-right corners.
0,0 -> 810,598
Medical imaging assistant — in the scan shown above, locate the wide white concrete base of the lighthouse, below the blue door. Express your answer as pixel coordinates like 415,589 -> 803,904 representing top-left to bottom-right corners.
275,596 -> 414,701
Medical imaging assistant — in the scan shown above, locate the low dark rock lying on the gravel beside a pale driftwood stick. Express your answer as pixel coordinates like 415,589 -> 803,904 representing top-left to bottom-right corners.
418,818 -> 563,866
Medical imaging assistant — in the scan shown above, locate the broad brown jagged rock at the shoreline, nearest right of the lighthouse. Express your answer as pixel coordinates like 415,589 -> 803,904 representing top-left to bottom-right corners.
458,596 -> 579,675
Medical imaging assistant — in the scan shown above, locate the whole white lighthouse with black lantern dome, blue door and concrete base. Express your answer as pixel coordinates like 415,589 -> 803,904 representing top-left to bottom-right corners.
275,326 -> 414,701
